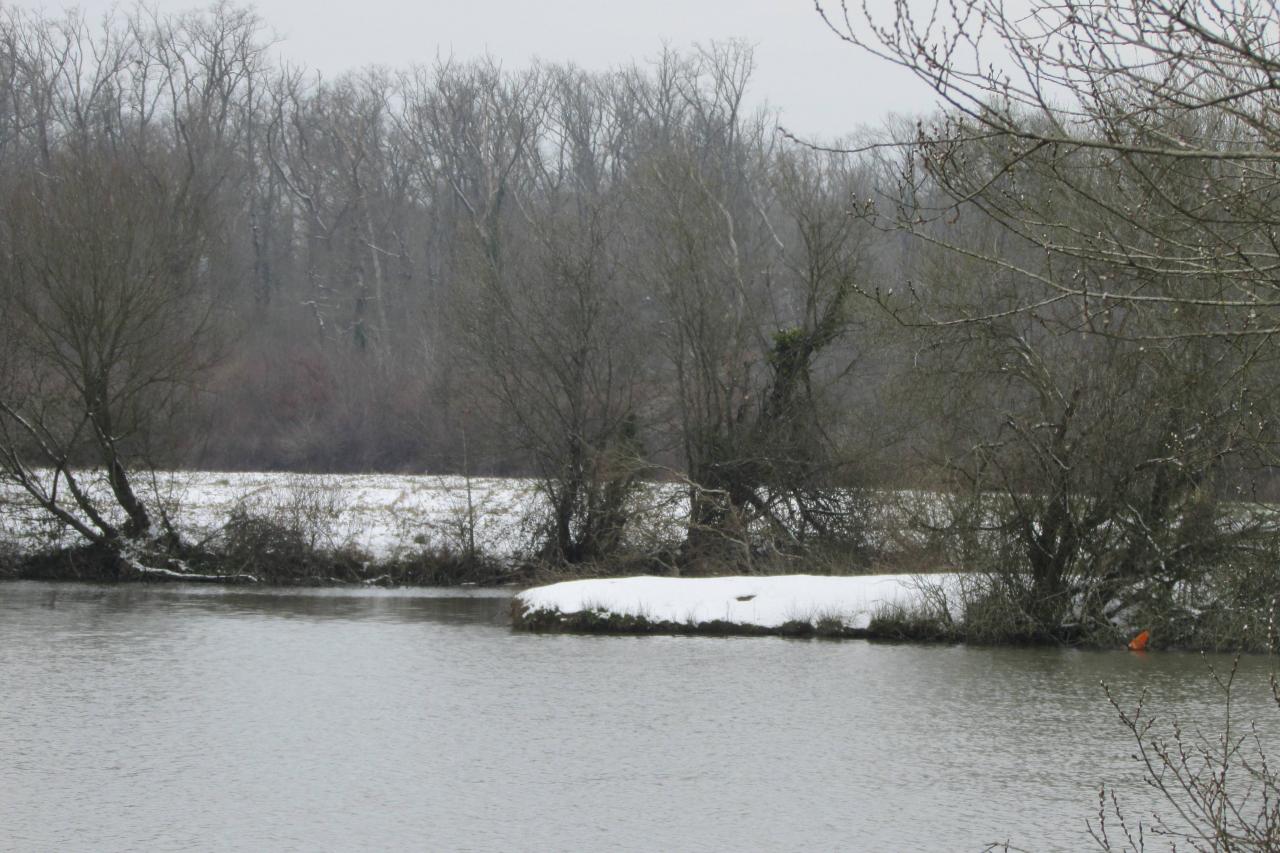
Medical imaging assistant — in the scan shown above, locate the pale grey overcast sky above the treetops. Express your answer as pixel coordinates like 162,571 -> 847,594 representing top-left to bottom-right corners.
35,0 -> 932,136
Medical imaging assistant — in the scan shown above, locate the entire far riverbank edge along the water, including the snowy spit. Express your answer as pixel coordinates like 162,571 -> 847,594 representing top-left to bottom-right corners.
0,558 -> 1271,652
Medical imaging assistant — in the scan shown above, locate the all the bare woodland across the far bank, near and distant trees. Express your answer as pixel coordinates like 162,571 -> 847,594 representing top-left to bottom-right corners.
0,0 -> 1280,633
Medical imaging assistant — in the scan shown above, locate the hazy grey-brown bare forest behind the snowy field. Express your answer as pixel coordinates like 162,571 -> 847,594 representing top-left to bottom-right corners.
0,6 -> 937,474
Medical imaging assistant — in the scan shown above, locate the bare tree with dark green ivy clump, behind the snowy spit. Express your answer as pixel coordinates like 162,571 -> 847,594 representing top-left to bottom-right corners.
636,45 -> 869,569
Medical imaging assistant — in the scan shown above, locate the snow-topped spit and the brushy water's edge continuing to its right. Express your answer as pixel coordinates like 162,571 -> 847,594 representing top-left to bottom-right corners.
512,573 -> 1249,652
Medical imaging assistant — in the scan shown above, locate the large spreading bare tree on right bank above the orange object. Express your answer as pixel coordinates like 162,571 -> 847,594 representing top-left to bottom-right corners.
798,0 -> 1280,635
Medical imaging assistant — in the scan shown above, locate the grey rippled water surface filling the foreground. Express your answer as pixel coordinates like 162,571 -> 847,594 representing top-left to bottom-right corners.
0,583 -> 1274,850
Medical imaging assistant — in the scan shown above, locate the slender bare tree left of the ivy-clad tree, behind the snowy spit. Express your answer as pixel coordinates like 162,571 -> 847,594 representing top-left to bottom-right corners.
449,68 -> 644,562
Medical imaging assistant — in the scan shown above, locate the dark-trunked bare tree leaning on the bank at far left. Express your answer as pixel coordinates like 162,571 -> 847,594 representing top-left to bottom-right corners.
0,6 -> 260,555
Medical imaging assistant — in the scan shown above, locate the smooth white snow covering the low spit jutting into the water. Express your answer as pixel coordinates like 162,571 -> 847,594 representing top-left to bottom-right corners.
517,574 -> 959,629
